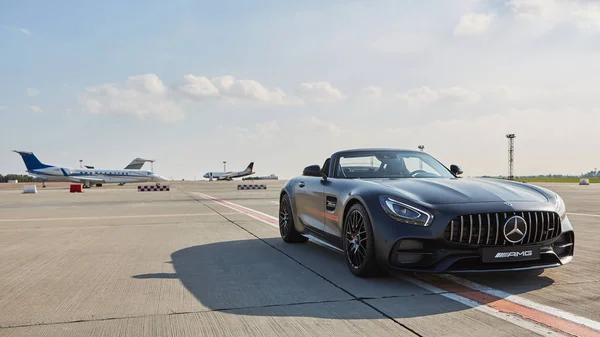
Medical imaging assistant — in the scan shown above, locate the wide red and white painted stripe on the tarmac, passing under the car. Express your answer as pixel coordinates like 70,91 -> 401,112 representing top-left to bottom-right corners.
193,192 -> 600,337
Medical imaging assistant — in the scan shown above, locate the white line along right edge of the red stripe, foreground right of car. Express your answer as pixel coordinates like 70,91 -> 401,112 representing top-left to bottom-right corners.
440,274 -> 600,331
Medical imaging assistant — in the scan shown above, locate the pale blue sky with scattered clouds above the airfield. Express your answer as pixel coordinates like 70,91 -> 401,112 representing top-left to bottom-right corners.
0,0 -> 600,180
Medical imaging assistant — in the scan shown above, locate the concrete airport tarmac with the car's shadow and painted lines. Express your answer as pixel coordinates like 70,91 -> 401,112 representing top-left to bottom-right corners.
0,181 -> 600,337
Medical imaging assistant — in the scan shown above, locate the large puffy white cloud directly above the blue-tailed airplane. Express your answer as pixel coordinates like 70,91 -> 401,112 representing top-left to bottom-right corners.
80,74 -> 185,122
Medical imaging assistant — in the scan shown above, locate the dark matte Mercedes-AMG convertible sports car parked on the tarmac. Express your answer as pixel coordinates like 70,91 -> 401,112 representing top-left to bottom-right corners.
279,149 -> 574,276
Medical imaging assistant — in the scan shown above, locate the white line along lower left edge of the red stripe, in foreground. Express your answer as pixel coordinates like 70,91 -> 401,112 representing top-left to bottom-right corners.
398,275 -> 566,336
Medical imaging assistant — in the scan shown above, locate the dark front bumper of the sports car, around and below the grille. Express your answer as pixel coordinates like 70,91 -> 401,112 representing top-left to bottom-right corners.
373,202 -> 575,273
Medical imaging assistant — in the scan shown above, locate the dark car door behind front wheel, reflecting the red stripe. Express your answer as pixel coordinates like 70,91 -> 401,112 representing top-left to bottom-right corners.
294,176 -> 325,230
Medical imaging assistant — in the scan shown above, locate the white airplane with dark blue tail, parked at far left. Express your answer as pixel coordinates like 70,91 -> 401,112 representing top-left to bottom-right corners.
13,150 -> 168,187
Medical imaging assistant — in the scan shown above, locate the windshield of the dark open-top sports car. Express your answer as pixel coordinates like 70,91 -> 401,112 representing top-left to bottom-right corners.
335,151 -> 454,179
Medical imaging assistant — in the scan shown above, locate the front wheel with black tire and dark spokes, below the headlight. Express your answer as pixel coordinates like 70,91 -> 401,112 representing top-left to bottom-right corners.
342,203 -> 384,277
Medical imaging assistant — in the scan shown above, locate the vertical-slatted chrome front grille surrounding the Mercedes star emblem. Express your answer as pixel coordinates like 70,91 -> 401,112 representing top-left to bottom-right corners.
444,212 -> 561,246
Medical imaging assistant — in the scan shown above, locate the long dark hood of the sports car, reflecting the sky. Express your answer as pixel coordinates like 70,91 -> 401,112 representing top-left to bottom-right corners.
370,178 -> 548,205
